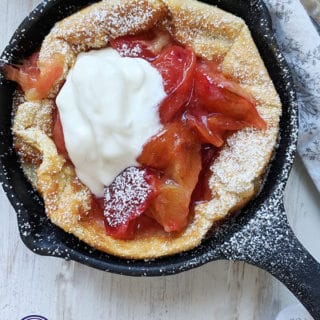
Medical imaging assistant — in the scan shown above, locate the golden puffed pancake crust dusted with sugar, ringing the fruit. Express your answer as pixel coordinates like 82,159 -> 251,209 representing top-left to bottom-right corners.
13,0 -> 281,259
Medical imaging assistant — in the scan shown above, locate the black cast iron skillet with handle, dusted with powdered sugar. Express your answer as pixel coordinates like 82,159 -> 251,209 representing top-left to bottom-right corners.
0,0 -> 320,319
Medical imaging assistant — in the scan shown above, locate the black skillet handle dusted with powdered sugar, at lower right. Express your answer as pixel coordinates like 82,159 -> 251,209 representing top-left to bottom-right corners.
245,200 -> 320,320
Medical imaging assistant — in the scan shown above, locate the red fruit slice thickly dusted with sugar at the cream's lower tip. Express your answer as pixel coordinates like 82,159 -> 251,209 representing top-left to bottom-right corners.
104,167 -> 158,239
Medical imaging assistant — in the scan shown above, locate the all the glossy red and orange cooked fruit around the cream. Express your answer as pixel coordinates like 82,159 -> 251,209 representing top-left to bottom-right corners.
5,30 -> 267,239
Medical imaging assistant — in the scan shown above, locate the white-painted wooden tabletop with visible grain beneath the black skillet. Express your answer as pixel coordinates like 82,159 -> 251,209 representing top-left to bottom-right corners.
0,0 -> 320,320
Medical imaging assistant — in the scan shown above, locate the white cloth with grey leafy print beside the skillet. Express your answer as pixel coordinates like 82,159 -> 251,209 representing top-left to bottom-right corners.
265,0 -> 320,192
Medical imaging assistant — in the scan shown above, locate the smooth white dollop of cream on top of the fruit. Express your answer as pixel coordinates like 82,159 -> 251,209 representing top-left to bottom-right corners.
56,48 -> 165,197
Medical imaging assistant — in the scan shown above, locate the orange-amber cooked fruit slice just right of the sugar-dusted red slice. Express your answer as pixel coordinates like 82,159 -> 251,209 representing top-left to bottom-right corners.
137,122 -> 201,232
